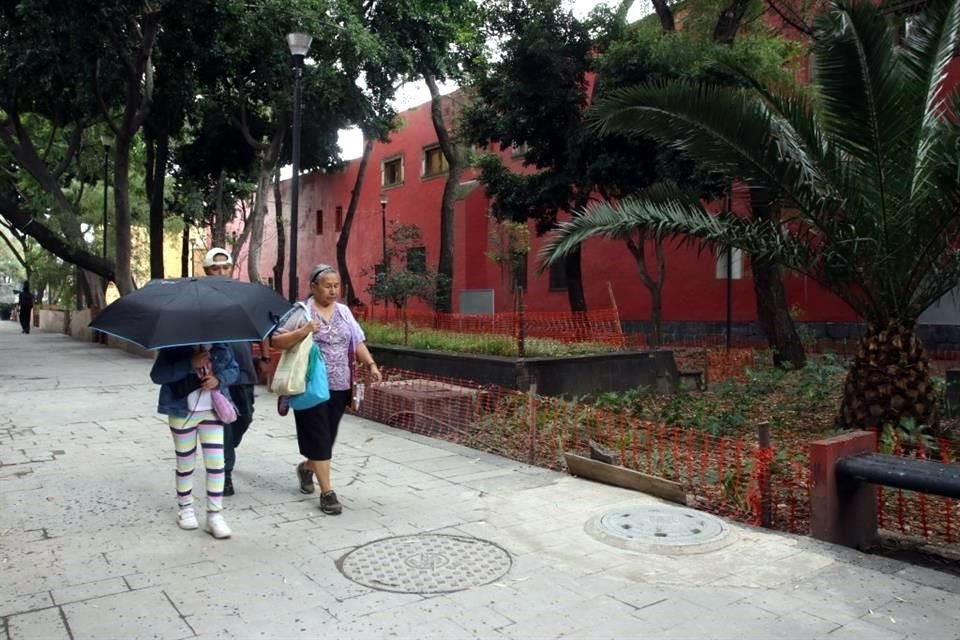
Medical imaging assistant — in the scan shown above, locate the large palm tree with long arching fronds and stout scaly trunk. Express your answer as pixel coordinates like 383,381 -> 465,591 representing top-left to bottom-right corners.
542,0 -> 960,428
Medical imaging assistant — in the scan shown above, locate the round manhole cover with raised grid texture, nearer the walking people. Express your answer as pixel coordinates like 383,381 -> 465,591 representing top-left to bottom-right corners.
337,534 -> 512,593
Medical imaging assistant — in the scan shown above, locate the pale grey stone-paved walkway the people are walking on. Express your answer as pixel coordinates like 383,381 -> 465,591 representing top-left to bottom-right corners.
0,322 -> 960,640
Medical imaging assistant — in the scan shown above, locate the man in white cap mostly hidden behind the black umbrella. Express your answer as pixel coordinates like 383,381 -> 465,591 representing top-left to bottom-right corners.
203,247 -> 270,496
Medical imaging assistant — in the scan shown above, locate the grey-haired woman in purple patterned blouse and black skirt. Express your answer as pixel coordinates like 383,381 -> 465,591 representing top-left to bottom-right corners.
271,264 -> 381,515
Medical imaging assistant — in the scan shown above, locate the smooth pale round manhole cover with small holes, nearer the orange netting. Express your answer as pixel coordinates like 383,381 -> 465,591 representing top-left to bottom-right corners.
586,505 -> 733,554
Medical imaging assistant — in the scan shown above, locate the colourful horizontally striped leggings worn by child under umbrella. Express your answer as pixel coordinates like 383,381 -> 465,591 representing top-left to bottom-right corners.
167,411 -> 224,511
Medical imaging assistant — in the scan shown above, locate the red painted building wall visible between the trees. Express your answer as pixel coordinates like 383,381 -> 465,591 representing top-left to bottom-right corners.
238,94 -> 856,322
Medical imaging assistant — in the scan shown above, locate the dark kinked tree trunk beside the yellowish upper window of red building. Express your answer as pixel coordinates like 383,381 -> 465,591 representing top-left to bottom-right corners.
423,73 -> 464,313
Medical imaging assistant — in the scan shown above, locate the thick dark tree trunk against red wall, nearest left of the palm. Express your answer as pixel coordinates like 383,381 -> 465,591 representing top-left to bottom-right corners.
751,252 -> 807,369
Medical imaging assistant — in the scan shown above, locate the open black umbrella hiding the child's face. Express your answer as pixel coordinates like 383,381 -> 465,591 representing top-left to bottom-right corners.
90,276 -> 291,349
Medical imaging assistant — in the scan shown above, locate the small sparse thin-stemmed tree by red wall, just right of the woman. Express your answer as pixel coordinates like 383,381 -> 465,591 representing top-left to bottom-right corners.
364,223 -> 449,344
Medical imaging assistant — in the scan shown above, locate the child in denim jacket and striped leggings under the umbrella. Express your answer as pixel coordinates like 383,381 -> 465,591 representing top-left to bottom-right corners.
150,343 -> 240,538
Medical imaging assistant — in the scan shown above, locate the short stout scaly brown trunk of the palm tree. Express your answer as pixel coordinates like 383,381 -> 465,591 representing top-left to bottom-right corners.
837,324 -> 938,429
